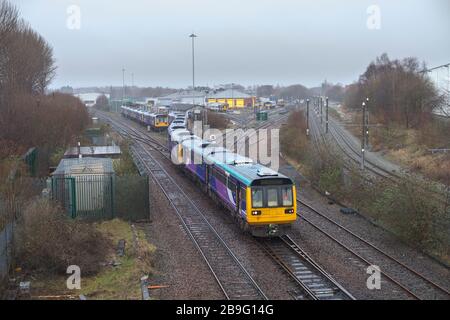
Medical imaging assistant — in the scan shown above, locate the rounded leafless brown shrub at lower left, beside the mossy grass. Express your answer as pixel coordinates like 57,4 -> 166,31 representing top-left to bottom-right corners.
16,198 -> 110,274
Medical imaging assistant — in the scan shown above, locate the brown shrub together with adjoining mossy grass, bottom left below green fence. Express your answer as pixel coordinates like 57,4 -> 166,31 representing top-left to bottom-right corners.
11,199 -> 155,300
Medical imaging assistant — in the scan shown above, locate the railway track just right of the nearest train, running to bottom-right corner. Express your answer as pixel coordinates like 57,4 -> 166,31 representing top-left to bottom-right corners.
297,199 -> 450,300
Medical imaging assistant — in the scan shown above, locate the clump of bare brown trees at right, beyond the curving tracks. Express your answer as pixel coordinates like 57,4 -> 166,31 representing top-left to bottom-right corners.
345,54 -> 442,128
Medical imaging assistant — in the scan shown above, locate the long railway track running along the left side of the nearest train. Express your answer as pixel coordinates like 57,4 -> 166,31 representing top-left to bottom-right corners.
96,112 -> 267,300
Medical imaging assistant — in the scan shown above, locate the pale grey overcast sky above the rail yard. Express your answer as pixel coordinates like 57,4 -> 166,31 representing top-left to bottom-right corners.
12,0 -> 450,87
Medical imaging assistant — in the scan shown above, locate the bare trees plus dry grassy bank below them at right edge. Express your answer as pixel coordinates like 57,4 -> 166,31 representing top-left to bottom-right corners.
343,54 -> 450,185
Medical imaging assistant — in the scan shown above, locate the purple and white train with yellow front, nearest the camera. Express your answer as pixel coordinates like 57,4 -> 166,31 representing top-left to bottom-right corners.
169,129 -> 297,237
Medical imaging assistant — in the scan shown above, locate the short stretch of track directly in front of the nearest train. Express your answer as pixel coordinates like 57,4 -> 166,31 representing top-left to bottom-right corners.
261,235 -> 355,300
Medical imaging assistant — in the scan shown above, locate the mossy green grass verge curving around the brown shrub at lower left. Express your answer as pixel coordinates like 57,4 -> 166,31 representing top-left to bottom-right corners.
28,219 -> 155,300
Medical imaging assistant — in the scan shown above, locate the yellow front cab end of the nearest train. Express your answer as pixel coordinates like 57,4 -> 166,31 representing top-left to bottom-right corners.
246,178 -> 297,237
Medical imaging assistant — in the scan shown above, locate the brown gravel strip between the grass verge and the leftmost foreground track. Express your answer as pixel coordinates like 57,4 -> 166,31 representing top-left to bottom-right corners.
138,169 -> 224,300
